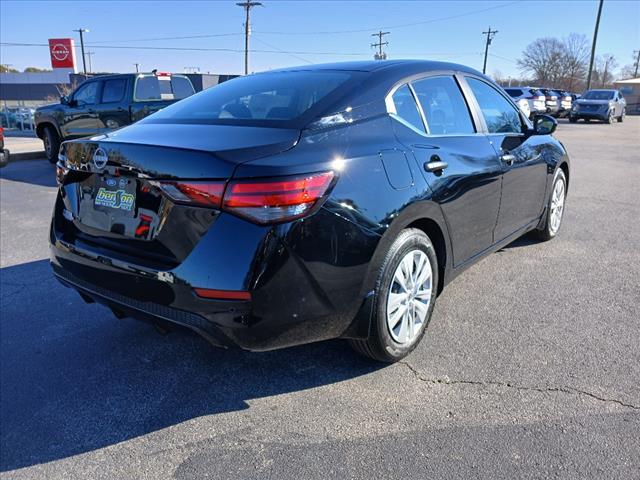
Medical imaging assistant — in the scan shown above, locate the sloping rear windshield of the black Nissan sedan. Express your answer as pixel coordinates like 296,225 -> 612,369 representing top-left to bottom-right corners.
145,71 -> 353,126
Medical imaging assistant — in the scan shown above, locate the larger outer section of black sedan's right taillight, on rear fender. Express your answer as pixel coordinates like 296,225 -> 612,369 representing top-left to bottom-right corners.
222,172 -> 333,224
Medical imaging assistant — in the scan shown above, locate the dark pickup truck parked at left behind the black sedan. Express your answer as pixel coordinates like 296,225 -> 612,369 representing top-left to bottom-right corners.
34,71 -> 195,163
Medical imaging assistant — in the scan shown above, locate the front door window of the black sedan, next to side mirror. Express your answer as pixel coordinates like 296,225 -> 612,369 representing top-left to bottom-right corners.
467,77 -> 522,133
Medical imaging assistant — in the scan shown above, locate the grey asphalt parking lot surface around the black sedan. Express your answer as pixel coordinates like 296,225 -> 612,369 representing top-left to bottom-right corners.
0,117 -> 640,479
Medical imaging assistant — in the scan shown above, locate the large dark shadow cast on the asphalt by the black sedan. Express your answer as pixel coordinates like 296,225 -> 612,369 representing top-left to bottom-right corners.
0,260 -> 381,471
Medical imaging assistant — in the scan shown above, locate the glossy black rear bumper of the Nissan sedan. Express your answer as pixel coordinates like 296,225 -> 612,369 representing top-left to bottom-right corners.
50,201 -> 378,351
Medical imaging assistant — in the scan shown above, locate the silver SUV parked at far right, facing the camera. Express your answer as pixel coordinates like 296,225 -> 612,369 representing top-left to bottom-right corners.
569,90 -> 627,123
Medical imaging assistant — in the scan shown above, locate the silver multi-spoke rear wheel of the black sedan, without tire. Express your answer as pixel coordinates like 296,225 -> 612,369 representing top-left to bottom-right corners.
387,250 -> 433,344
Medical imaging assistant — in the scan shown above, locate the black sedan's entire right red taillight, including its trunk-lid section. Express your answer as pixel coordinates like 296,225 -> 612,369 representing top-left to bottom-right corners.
158,172 -> 334,224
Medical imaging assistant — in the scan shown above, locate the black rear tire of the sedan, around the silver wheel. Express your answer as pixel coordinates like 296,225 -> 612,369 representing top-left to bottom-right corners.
349,228 -> 438,363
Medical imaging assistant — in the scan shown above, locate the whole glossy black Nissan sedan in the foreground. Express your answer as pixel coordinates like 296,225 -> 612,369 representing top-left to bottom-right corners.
50,61 -> 569,362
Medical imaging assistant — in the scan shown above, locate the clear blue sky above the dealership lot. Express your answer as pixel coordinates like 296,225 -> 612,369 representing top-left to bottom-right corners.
0,0 -> 640,78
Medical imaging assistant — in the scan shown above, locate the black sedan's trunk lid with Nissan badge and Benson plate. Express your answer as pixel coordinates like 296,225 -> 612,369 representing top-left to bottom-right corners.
58,124 -> 300,265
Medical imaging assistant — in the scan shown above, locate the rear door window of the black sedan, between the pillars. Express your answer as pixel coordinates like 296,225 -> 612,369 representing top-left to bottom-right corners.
411,76 -> 475,135
